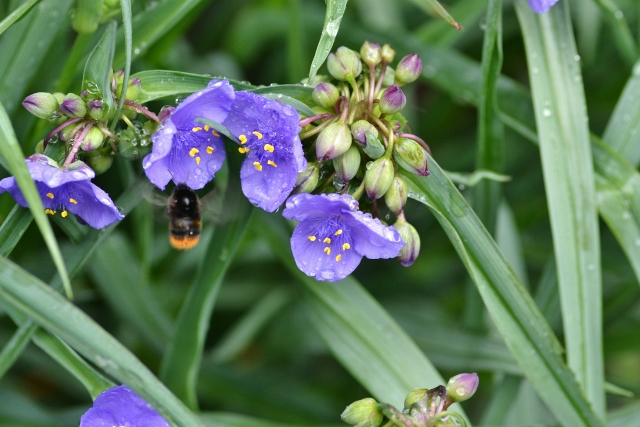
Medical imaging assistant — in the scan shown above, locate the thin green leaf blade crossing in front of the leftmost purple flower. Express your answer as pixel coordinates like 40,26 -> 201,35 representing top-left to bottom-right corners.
0,103 -> 73,298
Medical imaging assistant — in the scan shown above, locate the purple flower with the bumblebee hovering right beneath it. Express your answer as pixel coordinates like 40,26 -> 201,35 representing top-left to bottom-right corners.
142,80 -> 234,190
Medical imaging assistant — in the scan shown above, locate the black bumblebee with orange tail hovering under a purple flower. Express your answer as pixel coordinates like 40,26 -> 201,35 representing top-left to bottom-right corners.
165,184 -> 202,250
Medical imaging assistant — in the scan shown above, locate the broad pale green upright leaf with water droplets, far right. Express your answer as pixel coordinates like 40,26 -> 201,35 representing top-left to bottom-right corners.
516,0 -> 605,418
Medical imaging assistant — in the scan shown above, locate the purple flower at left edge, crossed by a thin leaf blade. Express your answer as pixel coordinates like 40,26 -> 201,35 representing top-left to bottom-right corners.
0,154 -> 124,228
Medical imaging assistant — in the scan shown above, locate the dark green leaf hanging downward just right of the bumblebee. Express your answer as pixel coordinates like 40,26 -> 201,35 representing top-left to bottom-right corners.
160,150 -> 253,409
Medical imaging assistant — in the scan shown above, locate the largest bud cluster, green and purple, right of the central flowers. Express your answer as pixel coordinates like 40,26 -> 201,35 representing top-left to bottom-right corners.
294,41 -> 430,266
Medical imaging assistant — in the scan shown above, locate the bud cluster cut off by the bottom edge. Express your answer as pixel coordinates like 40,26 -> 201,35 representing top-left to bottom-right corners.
340,374 -> 479,427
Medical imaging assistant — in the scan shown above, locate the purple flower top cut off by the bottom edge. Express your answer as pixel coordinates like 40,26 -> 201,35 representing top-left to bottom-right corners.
80,385 -> 171,427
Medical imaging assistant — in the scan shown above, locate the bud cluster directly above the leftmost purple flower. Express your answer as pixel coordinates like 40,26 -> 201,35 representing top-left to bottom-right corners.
22,71 -> 158,173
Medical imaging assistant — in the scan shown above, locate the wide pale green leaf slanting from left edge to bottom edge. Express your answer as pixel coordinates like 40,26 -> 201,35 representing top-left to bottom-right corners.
0,258 -> 202,427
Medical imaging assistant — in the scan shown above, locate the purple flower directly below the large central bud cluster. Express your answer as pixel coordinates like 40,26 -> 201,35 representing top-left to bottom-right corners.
282,194 -> 405,282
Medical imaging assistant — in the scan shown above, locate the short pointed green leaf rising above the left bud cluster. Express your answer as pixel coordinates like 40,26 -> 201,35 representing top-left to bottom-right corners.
82,21 -> 117,111
